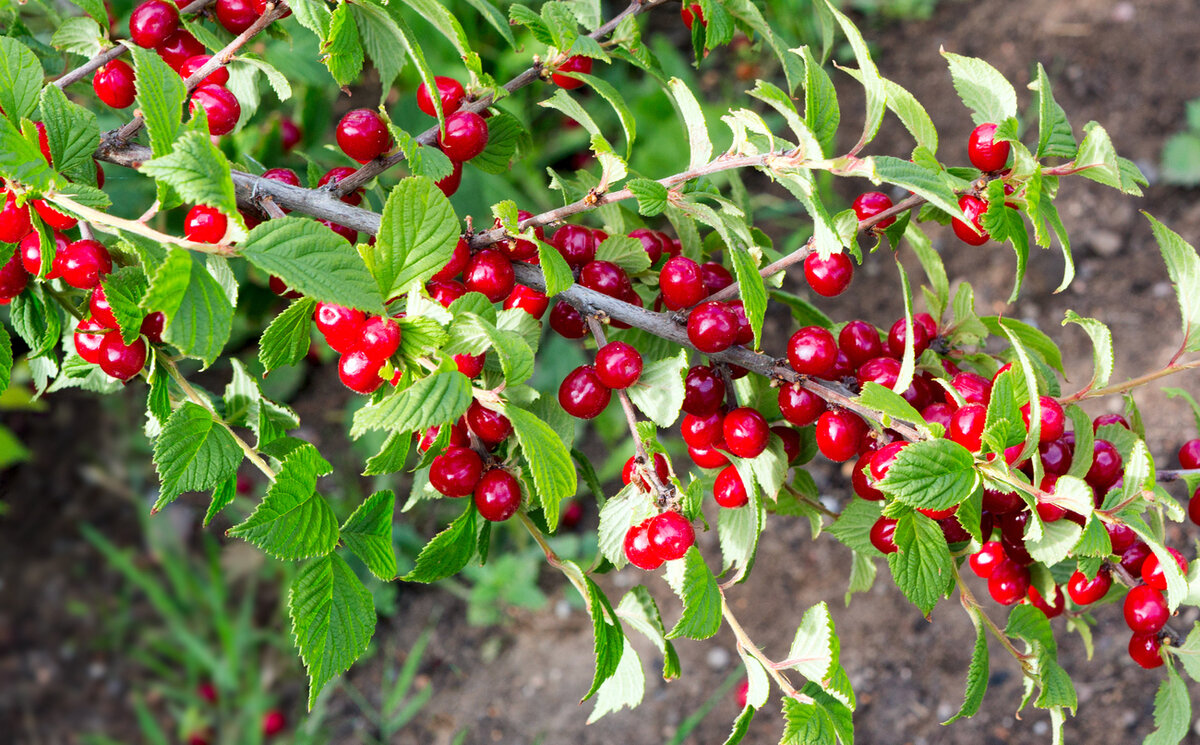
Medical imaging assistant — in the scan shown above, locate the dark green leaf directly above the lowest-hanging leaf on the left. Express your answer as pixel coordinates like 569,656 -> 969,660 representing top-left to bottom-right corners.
229,443 -> 338,561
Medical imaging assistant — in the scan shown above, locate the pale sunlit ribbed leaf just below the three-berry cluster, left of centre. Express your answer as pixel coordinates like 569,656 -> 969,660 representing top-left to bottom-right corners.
350,371 -> 472,438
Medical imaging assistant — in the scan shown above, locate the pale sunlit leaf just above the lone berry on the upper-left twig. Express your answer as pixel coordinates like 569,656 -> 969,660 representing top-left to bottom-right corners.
139,130 -> 238,220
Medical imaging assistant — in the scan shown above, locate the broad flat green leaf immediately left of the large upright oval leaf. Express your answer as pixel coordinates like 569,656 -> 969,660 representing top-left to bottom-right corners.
241,217 -> 383,313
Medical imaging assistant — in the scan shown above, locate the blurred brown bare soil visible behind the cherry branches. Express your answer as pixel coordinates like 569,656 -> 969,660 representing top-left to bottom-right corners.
7,0 -> 1200,745
